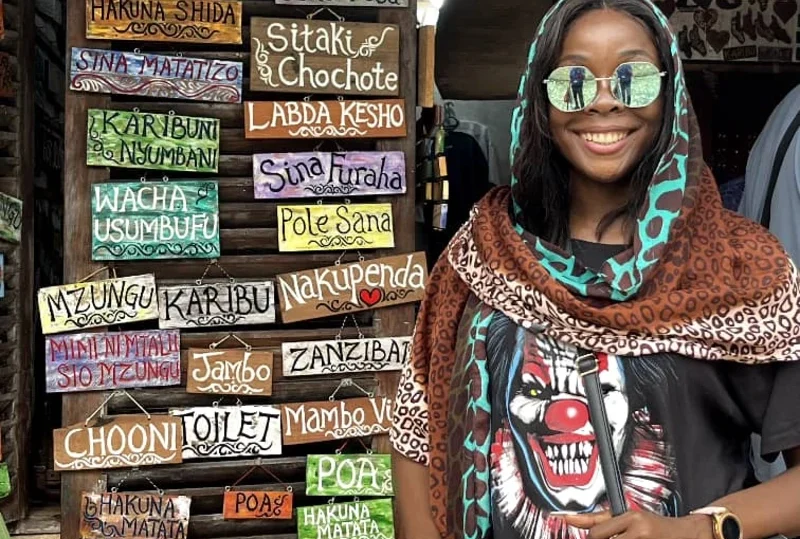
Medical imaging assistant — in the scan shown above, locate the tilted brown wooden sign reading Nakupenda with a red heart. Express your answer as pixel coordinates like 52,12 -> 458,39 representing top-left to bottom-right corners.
278,252 -> 428,322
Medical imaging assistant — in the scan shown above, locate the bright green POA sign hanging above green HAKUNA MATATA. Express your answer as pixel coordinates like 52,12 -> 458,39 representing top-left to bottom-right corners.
306,454 -> 394,496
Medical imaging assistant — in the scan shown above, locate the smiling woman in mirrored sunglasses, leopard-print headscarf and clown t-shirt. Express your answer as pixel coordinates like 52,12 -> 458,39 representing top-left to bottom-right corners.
392,0 -> 800,539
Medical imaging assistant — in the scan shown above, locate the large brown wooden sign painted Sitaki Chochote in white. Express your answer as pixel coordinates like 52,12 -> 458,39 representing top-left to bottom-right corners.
250,17 -> 400,96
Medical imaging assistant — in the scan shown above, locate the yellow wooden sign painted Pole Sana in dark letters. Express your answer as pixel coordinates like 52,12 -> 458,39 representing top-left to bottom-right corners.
278,204 -> 394,252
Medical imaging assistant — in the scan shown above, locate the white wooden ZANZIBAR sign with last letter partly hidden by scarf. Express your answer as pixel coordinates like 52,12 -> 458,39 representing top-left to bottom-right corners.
281,337 -> 411,377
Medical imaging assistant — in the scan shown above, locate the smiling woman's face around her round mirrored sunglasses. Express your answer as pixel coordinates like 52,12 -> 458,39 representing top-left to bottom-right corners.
550,9 -> 663,183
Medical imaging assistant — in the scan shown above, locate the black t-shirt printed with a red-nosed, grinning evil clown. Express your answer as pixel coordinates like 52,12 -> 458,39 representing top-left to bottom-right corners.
486,242 -> 800,539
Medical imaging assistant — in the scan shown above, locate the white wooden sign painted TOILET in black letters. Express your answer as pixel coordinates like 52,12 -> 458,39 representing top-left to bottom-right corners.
170,406 -> 282,460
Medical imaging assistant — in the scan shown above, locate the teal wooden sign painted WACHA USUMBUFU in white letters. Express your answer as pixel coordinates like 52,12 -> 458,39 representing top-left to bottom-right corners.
92,180 -> 220,260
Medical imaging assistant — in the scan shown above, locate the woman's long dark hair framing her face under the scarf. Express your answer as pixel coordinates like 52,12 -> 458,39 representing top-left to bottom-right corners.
514,0 -> 677,247
